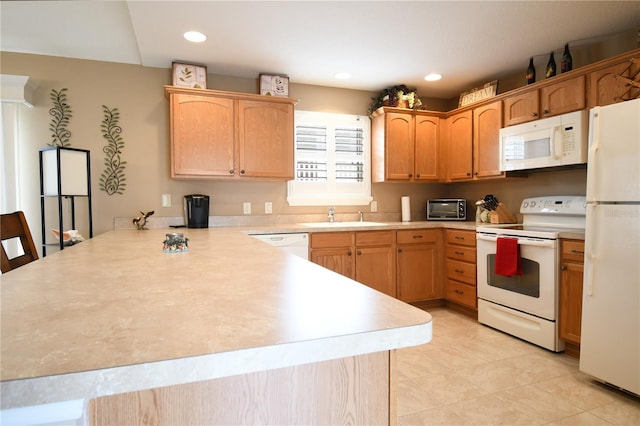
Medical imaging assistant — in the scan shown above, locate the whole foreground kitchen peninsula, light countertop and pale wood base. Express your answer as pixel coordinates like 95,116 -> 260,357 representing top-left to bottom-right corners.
0,228 -> 431,424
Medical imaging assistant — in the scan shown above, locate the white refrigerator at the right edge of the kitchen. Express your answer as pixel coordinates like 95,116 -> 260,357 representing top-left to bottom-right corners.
580,99 -> 640,395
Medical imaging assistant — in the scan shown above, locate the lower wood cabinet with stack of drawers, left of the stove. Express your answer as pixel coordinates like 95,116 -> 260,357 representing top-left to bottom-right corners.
444,229 -> 478,309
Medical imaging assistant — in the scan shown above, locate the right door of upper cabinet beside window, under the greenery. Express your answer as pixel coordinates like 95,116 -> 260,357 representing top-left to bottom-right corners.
414,115 -> 440,180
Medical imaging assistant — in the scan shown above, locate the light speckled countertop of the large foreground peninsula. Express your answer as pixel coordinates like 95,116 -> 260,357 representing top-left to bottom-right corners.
0,228 -> 431,409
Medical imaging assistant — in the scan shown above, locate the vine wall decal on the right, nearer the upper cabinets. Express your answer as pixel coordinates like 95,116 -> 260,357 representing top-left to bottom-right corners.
100,105 -> 127,195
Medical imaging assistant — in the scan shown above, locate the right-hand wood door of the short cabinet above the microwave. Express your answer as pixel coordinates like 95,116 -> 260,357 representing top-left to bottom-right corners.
540,75 -> 587,118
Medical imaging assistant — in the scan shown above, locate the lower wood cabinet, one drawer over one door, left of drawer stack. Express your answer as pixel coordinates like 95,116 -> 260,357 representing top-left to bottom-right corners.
396,229 -> 444,302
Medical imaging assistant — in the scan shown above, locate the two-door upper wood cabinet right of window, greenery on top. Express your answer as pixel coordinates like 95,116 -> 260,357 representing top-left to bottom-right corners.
371,108 -> 443,182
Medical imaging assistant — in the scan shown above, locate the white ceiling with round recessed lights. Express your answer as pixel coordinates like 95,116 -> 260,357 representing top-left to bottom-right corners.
0,0 -> 640,98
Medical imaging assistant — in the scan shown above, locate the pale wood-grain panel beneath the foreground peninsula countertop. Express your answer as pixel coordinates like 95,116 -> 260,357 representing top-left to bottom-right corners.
89,351 -> 396,426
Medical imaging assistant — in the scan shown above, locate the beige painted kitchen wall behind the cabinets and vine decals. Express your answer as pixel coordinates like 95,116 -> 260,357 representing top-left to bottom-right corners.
0,29 -> 637,243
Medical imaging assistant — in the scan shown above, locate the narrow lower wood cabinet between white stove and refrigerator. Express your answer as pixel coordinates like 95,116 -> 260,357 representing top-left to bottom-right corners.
558,240 -> 584,345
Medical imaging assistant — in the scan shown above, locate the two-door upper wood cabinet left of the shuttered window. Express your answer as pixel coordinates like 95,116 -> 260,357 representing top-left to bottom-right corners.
165,86 -> 295,180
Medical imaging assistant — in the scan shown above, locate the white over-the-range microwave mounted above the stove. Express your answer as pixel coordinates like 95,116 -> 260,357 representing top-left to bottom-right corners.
500,110 -> 589,171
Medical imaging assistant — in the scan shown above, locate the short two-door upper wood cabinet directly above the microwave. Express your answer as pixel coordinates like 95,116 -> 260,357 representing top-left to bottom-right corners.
504,75 -> 586,126
